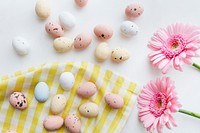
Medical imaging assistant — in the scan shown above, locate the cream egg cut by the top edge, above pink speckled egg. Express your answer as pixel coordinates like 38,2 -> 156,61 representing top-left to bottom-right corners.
35,0 -> 51,19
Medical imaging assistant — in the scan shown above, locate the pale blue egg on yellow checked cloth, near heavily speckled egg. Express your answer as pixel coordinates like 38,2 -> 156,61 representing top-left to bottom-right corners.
34,82 -> 49,102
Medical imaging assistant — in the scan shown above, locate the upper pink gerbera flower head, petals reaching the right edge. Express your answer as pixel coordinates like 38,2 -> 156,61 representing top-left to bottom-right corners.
148,23 -> 200,74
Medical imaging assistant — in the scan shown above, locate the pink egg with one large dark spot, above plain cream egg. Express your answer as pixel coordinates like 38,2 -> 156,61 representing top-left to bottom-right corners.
94,24 -> 113,41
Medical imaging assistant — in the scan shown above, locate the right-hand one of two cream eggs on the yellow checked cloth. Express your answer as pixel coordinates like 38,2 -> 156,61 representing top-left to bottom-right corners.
79,102 -> 99,118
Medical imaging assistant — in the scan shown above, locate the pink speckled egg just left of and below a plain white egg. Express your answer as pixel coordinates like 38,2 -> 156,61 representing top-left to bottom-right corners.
45,22 -> 64,38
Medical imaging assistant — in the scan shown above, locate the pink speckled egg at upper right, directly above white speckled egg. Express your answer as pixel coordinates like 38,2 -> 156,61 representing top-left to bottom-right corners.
125,3 -> 144,19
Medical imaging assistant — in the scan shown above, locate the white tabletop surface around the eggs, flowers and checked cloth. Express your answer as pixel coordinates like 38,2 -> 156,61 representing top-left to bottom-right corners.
0,0 -> 200,133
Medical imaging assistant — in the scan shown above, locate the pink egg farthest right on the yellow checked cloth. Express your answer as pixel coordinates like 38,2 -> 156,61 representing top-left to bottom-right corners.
104,93 -> 124,109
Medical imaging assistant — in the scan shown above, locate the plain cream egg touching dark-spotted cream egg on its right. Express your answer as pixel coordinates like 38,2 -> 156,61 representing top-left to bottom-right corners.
95,42 -> 111,61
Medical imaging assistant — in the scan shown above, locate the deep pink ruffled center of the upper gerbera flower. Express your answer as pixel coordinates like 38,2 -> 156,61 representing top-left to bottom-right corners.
161,35 -> 187,59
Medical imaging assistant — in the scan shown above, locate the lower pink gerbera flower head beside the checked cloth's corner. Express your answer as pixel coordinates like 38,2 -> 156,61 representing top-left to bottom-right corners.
138,77 -> 181,133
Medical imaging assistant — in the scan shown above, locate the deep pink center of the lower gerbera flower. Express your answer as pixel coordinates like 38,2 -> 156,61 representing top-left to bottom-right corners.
149,92 -> 167,117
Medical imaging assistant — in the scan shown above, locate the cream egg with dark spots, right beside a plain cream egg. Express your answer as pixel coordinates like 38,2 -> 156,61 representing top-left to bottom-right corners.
111,47 -> 130,62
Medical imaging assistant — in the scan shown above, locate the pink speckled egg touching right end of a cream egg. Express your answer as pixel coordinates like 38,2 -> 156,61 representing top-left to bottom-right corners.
74,33 -> 92,49
